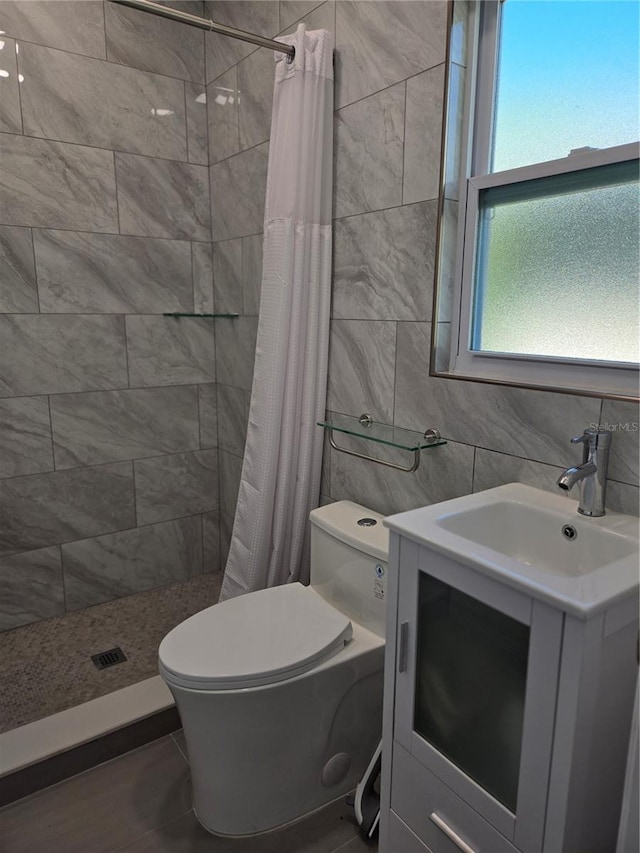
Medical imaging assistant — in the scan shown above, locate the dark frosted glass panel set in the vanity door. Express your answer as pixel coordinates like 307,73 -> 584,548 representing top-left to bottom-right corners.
414,572 -> 530,813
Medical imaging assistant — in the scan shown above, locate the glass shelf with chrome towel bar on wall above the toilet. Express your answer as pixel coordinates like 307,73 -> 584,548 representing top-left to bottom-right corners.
318,414 -> 447,473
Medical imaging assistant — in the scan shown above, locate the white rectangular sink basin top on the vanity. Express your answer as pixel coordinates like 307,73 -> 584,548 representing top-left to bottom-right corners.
385,483 -> 639,617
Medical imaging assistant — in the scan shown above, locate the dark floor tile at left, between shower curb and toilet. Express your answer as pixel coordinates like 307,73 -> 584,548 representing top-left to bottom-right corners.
0,735 -> 191,853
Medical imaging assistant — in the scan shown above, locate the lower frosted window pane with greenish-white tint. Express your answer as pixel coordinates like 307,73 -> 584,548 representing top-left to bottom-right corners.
471,161 -> 640,363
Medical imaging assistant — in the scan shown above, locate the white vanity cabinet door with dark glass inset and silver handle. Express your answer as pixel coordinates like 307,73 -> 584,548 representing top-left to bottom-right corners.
394,540 -> 563,853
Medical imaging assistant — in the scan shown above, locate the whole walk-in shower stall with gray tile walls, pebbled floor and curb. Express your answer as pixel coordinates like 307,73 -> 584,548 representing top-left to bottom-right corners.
0,0 -> 304,802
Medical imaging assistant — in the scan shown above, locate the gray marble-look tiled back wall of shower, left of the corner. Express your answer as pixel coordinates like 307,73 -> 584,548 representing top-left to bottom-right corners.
0,0 -> 219,629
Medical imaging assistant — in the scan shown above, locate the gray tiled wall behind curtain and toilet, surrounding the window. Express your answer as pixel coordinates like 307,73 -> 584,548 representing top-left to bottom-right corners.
205,0 -> 640,564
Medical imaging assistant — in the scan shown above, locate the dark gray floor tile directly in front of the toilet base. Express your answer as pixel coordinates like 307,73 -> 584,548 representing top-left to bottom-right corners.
118,800 -> 362,853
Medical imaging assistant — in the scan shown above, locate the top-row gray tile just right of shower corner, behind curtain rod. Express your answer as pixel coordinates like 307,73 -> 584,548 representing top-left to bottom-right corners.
205,0 -> 280,83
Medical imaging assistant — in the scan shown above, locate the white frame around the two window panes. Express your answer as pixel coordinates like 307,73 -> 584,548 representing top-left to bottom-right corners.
444,0 -> 640,400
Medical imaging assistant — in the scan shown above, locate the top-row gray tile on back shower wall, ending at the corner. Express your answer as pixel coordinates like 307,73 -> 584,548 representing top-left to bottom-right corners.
104,3 -> 204,83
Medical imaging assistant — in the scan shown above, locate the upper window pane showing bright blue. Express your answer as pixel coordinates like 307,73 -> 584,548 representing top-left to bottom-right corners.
491,0 -> 640,172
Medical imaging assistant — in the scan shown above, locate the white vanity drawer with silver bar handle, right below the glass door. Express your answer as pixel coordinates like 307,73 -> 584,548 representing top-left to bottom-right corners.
391,742 -> 517,853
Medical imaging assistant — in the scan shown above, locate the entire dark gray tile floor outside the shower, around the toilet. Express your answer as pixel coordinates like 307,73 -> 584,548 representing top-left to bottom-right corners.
0,732 -> 376,853
